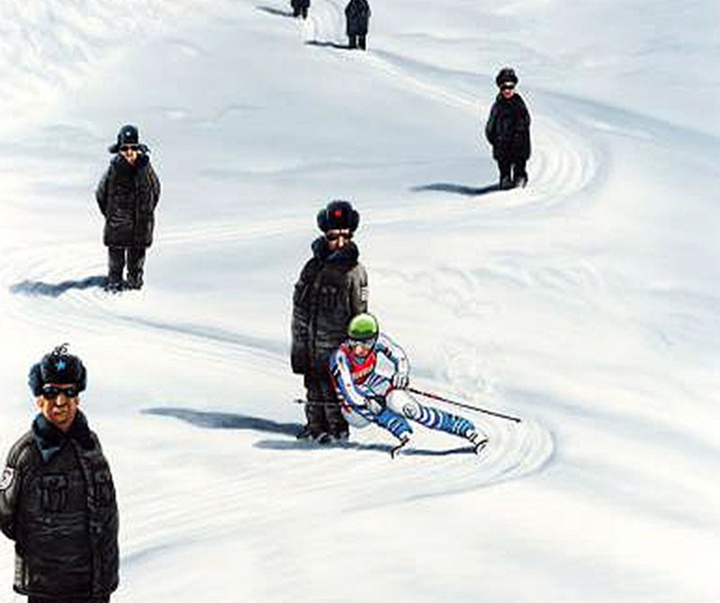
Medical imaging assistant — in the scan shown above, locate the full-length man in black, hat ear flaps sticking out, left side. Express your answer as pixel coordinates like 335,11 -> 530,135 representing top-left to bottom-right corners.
95,125 -> 160,291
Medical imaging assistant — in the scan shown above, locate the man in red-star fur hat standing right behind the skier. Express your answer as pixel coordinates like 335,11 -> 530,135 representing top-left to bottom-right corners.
291,201 -> 368,443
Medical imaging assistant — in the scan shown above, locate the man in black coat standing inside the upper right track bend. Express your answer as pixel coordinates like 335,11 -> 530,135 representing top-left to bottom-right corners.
485,67 -> 530,189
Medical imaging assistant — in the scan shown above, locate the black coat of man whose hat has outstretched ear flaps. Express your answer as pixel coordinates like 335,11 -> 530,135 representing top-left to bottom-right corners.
95,154 -> 160,247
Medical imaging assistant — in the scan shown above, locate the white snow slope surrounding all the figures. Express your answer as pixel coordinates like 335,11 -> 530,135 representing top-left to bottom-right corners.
0,0 -> 720,603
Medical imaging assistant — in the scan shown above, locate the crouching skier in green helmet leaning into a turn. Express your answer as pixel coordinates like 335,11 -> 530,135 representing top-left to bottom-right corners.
331,314 -> 487,457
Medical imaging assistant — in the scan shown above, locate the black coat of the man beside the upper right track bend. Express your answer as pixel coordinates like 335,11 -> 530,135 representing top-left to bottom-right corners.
485,92 -> 530,161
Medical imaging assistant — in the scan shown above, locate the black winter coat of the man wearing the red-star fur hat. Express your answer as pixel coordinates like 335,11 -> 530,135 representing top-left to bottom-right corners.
291,237 -> 368,377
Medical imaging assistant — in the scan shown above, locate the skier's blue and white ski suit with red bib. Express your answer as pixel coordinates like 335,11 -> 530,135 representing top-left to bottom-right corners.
330,333 -> 475,439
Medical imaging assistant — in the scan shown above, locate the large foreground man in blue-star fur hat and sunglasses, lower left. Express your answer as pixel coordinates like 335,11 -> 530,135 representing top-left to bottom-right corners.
0,345 -> 119,603
